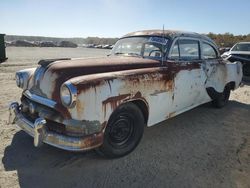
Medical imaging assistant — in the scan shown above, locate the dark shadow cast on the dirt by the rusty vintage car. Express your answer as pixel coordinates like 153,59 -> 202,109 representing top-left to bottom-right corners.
2,101 -> 250,187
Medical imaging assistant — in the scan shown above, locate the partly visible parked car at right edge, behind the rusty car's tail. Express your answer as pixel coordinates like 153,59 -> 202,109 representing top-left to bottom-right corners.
221,42 -> 250,76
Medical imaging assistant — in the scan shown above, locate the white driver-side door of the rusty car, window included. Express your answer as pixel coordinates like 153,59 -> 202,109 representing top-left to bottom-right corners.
168,37 -> 209,113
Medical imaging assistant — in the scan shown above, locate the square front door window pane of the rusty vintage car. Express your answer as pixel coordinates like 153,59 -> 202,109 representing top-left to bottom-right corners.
179,39 -> 200,61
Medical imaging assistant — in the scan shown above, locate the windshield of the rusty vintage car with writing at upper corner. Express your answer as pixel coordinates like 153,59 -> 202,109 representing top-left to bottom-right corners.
111,36 -> 168,59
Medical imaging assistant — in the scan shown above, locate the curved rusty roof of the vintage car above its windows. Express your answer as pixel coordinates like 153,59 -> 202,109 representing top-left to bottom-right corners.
121,29 -> 215,44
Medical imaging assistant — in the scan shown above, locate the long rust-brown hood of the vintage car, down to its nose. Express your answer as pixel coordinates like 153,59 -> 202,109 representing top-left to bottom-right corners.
29,56 -> 160,101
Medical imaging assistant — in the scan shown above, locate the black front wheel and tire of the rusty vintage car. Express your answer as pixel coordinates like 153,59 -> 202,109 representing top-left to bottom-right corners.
98,103 -> 144,158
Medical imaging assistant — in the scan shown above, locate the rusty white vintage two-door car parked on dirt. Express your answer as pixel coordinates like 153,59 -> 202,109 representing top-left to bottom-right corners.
9,30 -> 242,158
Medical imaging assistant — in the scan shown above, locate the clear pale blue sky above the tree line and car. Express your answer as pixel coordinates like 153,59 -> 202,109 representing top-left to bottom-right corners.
0,0 -> 250,37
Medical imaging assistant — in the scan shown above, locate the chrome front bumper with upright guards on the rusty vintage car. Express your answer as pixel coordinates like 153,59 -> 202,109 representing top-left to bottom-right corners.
9,102 -> 104,151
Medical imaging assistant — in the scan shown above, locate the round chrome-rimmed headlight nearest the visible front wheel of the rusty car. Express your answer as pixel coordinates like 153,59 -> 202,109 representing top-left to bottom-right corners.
60,83 -> 77,108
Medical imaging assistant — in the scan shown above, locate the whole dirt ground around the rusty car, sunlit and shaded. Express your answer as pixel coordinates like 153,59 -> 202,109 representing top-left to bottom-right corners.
0,47 -> 250,188
